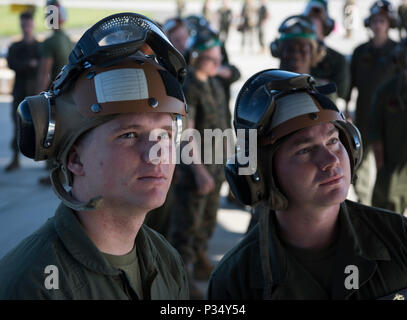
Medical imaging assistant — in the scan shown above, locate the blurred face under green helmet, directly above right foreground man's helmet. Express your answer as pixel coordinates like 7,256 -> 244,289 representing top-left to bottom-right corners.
280,39 -> 312,73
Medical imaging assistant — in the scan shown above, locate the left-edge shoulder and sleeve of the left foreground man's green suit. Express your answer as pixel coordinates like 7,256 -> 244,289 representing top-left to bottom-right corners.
0,218 -> 67,299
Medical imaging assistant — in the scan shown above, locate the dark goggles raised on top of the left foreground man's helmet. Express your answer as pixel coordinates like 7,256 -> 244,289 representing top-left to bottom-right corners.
53,12 -> 186,93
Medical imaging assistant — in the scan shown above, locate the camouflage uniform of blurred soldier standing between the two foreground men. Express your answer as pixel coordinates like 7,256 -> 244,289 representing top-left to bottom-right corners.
170,70 -> 227,263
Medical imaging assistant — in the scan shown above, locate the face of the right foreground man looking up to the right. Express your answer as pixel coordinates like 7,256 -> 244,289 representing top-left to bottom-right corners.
274,123 -> 351,208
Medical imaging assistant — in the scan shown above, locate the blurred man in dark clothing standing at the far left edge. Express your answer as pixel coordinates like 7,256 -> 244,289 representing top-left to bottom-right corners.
4,12 -> 40,172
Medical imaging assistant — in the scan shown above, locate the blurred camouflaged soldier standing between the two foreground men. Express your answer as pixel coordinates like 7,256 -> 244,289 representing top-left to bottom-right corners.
170,33 -> 228,299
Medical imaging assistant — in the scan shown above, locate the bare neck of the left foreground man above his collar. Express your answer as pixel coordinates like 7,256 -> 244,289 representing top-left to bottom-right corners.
77,208 -> 147,255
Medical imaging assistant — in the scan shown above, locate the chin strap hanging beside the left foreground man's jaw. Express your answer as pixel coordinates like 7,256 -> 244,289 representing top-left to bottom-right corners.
50,166 -> 103,211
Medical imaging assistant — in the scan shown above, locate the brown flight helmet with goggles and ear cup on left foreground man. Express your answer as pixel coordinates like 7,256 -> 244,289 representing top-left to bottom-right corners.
17,13 -> 187,211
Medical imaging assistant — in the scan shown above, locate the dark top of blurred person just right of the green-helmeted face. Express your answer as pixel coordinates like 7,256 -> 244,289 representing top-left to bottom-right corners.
311,47 -> 350,99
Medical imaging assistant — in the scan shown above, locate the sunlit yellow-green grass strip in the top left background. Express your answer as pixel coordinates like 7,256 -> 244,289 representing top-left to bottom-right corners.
0,5 -> 154,37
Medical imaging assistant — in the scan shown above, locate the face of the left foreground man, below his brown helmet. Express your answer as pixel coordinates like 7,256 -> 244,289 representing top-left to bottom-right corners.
75,113 -> 175,210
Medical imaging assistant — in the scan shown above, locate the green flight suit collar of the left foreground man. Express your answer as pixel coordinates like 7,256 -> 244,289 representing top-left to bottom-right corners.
54,203 -> 158,288
